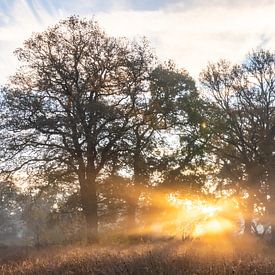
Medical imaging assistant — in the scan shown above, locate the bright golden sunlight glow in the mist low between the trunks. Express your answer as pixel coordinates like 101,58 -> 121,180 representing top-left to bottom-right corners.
116,184 -> 242,246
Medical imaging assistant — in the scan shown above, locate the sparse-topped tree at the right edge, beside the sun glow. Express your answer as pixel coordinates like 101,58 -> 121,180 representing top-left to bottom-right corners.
201,50 -> 275,240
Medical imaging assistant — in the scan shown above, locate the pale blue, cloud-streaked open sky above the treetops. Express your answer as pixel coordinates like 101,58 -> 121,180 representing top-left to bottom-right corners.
0,0 -> 275,85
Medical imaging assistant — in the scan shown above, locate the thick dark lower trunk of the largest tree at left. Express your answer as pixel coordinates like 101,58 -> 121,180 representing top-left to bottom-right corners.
80,176 -> 98,242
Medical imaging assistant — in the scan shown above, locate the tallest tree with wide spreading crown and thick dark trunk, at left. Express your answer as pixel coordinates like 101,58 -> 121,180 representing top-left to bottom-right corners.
1,17 -> 153,243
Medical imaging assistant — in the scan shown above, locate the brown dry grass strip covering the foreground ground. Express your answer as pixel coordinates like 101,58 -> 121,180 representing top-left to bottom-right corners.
0,242 -> 275,275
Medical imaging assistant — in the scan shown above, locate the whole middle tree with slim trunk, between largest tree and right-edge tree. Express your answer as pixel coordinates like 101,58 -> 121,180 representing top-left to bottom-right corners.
116,61 -> 211,231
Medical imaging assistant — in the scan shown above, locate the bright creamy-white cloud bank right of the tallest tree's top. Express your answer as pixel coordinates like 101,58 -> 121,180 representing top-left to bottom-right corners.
98,1 -> 275,77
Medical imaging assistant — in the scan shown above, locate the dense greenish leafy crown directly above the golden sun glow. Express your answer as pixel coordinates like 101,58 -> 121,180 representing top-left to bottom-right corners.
151,62 -> 210,190
